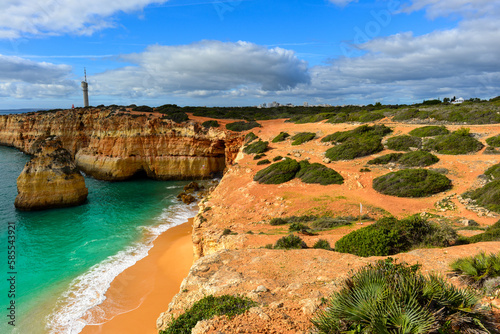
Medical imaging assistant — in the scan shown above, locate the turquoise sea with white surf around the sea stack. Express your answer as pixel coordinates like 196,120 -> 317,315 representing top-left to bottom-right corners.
0,147 -> 199,334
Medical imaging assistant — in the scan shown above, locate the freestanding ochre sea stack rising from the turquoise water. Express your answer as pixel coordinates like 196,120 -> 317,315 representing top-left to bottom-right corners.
14,137 -> 88,211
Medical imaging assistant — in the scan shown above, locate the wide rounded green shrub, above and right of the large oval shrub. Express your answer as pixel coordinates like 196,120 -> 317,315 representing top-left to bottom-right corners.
425,133 -> 484,155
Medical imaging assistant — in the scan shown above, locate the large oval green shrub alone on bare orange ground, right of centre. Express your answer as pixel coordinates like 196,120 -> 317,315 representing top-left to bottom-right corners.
373,169 -> 451,197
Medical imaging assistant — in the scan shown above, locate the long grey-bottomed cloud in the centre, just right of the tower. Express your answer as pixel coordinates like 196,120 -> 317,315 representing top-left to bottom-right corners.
90,41 -> 309,97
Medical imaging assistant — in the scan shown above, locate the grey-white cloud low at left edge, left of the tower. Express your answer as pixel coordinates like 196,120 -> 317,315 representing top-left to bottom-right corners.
0,55 -> 78,99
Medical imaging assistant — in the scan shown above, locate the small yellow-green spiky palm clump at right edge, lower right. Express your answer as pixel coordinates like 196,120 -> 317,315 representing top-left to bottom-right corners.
450,252 -> 500,287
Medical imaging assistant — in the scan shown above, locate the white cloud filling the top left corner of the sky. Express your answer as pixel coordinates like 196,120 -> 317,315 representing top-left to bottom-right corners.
0,0 -> 167,38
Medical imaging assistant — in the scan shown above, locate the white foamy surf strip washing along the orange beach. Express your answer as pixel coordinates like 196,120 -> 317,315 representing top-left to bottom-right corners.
47,204 -> 196,334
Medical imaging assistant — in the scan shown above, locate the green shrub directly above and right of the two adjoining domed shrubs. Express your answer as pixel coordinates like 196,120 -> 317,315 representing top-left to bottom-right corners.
325,136 -> 384,161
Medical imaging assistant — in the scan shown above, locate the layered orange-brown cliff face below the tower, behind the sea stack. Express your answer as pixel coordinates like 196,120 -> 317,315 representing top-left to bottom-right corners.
0,108 -> 242,181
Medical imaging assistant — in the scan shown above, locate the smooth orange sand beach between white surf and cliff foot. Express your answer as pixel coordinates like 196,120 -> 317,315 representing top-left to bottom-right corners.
81,219 -> 193,334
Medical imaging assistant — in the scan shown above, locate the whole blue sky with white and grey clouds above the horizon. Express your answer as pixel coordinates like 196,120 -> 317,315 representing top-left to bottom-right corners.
0,0 -> 500,109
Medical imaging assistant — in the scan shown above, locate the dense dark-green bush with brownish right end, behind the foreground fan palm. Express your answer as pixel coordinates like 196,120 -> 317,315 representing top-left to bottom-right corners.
335,216 -> 458,257
